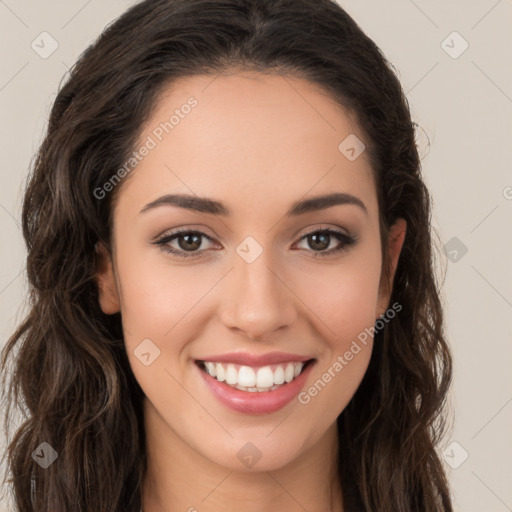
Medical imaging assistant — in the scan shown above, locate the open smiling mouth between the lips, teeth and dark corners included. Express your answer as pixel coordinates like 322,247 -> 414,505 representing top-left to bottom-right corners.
195,358 -> 316,393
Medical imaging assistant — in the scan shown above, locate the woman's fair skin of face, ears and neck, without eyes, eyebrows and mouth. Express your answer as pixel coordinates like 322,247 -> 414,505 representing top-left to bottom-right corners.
97,72 -> 406,512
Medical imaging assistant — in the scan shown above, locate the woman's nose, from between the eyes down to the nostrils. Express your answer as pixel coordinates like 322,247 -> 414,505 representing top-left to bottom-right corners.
219,250 -> 297,341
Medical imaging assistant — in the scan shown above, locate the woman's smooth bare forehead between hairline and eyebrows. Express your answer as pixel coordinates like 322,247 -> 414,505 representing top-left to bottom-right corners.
117,72 -> 375,218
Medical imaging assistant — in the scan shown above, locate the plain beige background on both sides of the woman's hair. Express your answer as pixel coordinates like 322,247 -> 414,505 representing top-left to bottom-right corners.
0,0 -> 512,512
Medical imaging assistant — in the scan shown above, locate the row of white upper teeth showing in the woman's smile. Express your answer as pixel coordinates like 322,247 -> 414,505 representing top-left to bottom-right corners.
204,361 -> 304,392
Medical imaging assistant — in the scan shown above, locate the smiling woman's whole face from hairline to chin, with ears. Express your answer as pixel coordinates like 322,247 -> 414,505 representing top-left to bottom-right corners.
98,73 -> 405,470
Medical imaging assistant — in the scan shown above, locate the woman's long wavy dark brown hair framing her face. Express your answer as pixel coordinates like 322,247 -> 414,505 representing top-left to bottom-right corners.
2,0 -> 452,512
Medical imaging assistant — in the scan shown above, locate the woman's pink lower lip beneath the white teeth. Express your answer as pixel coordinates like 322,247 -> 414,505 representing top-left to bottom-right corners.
195,361 -> 315,414
